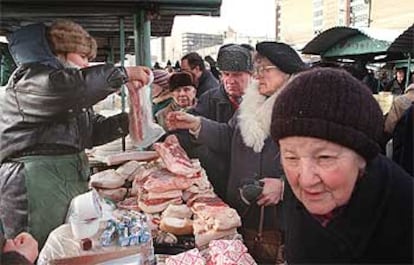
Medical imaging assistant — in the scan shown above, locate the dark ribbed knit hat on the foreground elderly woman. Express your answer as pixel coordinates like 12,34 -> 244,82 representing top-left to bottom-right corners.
271,68 -> 383,161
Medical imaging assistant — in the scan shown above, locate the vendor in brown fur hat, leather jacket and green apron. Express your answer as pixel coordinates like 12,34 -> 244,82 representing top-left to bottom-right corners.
0,20 -> 150,247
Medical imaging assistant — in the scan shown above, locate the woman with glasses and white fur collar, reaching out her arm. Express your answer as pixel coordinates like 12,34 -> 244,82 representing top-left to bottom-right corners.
168,42 -> 305,264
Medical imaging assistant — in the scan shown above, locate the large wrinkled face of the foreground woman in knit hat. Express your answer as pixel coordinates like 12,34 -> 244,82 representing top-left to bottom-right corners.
279,136 -> 366,215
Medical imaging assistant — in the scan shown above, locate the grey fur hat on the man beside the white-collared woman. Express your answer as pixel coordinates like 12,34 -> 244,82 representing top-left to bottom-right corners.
217,44 -> 253,72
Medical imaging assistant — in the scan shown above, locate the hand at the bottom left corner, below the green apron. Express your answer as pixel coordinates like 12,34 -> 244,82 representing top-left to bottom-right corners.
3,232 -> 39,263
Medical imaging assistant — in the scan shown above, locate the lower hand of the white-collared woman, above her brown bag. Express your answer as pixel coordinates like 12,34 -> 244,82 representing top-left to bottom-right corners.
257,178 -> 283,206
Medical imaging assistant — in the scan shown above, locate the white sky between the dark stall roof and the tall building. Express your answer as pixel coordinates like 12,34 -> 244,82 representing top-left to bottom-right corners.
173,0 -> 275,37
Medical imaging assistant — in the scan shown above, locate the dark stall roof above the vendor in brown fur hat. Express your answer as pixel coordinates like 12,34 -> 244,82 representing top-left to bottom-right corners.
0,0 -> 222,61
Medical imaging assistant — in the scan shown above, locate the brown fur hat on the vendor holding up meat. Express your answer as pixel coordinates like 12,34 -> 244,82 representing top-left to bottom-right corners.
48,19 -> 97,60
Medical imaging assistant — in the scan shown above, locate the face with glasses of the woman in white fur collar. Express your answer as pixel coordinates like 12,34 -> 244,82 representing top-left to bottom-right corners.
255,57 -> 289,96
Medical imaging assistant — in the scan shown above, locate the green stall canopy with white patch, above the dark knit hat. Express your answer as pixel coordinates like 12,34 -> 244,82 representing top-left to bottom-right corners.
302,27 -> 401,61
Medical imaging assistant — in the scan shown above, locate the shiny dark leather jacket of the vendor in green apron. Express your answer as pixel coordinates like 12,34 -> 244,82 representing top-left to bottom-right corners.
0,25 -> 128,161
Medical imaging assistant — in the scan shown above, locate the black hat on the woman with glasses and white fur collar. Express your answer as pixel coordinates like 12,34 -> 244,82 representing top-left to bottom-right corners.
256,41 -> 307,74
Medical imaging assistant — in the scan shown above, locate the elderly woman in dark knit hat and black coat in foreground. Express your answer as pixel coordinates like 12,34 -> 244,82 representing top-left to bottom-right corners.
271,68 -> 414,264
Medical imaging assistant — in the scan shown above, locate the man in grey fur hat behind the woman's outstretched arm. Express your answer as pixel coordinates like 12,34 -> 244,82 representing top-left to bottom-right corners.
179,44 -> 253,198
